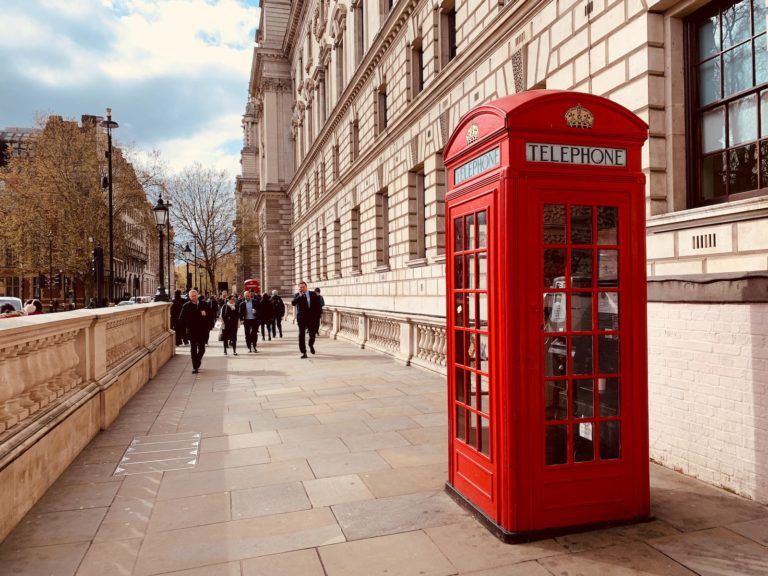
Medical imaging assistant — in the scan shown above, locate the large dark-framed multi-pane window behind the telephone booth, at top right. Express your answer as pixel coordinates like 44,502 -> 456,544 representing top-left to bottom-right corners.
686,0 -> 768,206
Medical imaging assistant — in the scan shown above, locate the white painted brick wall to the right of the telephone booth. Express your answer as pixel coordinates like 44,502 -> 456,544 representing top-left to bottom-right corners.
648,303 -> 768,502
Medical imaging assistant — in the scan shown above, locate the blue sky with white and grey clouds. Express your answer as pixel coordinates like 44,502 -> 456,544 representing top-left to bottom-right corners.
0,0 -> 259,180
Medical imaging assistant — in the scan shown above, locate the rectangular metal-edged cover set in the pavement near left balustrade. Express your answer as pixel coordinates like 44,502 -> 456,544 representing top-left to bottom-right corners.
112,432 -> 202,476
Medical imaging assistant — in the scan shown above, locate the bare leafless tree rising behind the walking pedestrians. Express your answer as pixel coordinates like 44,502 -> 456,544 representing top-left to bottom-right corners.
167,163 -> 236,290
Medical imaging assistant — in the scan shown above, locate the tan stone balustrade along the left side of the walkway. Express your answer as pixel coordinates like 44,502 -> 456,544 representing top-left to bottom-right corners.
0,303 -> 175,541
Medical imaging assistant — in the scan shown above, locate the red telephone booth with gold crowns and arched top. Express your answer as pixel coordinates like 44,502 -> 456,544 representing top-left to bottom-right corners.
444,90 -> 650,541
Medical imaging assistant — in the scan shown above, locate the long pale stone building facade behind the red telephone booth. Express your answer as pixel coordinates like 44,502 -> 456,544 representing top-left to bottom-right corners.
239,0 -> 768,501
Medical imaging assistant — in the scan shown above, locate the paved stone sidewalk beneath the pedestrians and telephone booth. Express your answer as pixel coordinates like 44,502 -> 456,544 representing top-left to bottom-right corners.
0,324 -> 768,576
